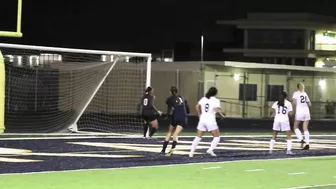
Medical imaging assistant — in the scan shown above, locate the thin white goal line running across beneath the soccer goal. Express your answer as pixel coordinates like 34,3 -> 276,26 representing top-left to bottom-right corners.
0,134 -> 336,140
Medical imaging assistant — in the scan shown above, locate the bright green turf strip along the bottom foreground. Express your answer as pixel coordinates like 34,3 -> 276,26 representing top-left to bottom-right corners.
0,157 -> 336,189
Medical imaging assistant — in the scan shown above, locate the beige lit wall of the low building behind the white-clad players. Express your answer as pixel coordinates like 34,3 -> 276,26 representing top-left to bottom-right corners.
204,66 -> 336,118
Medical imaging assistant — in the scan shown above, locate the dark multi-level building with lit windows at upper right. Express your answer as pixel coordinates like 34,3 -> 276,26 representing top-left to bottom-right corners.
217,13 -> 336,67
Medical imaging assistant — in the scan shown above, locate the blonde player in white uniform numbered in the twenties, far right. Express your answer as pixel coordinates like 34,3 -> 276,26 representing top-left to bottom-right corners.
293,83 -> 311,150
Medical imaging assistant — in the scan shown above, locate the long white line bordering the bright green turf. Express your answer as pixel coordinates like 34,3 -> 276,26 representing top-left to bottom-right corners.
0,155 -> 336,178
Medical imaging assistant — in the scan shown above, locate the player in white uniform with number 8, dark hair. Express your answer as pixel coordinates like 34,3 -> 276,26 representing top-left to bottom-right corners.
189,87 -> 225,157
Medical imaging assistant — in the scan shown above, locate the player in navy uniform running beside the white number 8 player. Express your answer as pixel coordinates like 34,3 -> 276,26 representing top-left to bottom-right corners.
161,86 -> 190,156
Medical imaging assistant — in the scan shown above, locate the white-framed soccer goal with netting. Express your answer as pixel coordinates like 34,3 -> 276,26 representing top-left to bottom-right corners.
0,43 -> 151,134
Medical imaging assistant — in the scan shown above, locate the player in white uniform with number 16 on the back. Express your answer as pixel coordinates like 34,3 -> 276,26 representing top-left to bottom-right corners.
269,92 -> 294,155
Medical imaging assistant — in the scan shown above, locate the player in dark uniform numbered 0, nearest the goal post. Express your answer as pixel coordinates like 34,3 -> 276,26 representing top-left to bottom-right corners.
141,87 -> 162,137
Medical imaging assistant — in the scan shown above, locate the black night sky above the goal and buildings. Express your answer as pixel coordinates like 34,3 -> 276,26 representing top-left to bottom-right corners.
0,0 -> 336,56
